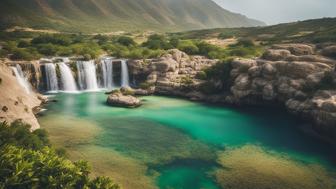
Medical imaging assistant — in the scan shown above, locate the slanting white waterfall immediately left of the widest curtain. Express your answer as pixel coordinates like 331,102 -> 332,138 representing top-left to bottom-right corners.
58,63 -> 77,92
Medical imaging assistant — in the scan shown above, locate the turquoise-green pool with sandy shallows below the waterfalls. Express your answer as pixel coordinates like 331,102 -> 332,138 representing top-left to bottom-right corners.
39,92 -> 335,189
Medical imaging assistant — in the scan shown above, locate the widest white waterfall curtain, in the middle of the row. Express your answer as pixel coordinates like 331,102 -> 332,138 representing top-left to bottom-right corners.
77,61 -> 98,91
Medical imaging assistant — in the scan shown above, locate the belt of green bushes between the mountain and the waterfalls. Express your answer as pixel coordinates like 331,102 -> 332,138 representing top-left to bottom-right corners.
0,31 -> 262,60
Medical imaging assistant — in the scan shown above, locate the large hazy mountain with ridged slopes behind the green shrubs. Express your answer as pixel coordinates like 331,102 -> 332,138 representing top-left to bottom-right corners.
0,0 -> 264,32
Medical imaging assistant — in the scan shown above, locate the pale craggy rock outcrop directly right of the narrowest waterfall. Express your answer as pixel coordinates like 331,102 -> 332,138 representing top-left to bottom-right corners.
128,49 -> 218,96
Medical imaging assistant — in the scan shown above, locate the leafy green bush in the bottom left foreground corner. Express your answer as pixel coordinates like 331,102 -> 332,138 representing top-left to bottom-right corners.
0,121 -> 120,189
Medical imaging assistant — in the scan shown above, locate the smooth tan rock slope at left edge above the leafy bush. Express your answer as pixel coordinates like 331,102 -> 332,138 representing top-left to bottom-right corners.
0,62 -> 44,130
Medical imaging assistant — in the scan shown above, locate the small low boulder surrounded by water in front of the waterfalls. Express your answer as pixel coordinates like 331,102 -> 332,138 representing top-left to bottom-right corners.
106,89 -> 141,108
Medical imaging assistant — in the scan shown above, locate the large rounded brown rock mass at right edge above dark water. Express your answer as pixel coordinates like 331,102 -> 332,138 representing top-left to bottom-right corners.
225,44 -> 336,143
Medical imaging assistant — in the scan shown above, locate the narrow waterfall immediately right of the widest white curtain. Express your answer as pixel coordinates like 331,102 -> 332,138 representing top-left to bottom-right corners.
101,58 -> 114,89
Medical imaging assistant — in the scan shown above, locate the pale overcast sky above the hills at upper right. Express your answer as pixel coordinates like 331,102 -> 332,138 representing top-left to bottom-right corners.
214,0 -> 336,24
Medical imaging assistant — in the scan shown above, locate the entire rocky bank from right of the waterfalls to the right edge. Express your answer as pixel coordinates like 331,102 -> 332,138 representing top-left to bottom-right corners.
130,44 -> 336,141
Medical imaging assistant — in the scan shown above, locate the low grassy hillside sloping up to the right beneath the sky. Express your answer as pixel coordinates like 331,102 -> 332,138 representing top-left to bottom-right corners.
174,18 -> 336,43
